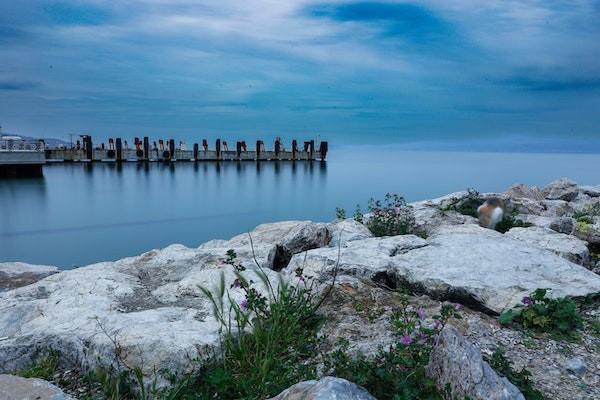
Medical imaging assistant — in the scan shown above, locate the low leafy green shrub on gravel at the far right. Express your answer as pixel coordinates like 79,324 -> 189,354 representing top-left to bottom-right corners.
499,289 -> 582,339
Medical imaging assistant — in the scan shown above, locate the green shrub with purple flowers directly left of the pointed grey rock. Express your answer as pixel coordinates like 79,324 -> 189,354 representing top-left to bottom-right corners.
323,297 -> 459,400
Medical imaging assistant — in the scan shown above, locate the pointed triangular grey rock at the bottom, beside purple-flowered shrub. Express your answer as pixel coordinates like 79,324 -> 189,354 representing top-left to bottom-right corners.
427,326 -> 525,400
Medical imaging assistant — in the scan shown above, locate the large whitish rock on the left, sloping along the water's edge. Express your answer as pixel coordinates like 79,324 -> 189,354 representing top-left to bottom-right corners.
0,222 -> 329,382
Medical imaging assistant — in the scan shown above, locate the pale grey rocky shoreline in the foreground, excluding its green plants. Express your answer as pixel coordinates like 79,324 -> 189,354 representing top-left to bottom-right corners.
0,179 -> 600,400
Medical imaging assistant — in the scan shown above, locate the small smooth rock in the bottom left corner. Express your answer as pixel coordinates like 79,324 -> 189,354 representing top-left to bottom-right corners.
0,375 -> 73,400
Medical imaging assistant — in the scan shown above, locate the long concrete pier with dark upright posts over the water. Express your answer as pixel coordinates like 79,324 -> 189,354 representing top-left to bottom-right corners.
0,135 -> 328,176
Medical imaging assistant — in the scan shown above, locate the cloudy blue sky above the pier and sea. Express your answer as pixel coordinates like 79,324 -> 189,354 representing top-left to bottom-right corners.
0,0 -> 600,152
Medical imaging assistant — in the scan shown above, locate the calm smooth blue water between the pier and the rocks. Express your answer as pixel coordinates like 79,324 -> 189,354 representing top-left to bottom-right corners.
0,149 -> 600,268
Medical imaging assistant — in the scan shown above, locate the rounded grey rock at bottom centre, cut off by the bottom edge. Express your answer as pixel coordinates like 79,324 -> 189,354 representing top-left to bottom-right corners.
271,376 -> 376,400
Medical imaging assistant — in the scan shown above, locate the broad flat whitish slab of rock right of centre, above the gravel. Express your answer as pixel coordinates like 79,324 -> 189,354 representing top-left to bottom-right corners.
285,224 -> 600,313
